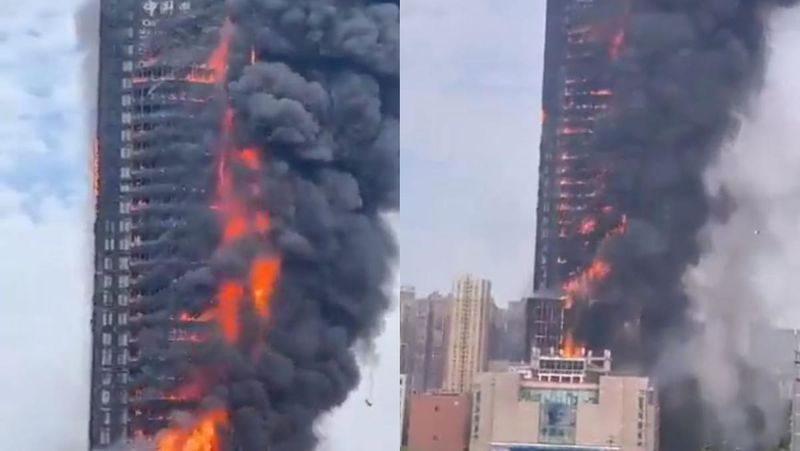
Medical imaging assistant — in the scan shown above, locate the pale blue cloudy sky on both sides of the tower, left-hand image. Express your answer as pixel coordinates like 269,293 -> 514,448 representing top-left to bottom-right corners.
0,0 -> 400,451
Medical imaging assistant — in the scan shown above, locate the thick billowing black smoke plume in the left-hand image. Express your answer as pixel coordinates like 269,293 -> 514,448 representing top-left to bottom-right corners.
134,0 -> 399,451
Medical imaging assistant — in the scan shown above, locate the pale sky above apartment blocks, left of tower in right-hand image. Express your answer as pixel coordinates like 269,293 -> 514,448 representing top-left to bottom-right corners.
400,0 -> 546,303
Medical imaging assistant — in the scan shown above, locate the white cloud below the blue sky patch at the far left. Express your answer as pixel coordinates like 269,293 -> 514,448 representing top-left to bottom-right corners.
0,186 -> 90,451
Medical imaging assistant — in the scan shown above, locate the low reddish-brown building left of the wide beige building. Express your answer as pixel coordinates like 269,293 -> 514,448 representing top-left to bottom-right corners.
408,393 -> 470,451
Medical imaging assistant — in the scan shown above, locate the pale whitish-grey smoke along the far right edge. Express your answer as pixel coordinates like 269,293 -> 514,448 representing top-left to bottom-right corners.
686,6 -> 800,448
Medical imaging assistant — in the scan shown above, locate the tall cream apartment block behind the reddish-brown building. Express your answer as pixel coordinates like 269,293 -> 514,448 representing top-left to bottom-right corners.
443,275 -> 493,393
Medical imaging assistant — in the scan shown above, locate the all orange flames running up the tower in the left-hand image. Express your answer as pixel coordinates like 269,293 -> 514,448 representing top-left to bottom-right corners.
157,21 -> 280,451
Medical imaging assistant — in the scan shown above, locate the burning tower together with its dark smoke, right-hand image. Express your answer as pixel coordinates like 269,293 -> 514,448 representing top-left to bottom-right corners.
529,0 -> 797,451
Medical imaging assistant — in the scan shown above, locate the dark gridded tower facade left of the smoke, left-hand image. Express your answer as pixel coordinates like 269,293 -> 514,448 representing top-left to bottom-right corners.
89,0 -> 217,449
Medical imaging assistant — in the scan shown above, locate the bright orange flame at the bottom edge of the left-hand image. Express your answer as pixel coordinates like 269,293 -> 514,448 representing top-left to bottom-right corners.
156,409 -> 228,451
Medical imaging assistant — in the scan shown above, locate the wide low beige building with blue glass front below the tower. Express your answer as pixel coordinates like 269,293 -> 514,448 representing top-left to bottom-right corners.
469,353 -> 658,451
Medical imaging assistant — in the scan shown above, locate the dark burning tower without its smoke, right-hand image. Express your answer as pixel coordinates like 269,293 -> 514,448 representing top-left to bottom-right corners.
527,0 -> 626,360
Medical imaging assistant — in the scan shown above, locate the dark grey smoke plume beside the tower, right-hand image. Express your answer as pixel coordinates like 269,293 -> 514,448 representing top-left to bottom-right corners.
577,0 -> 797,451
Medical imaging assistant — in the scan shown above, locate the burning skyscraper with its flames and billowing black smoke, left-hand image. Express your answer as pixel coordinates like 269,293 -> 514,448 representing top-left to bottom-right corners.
90,0 -> 399,451
